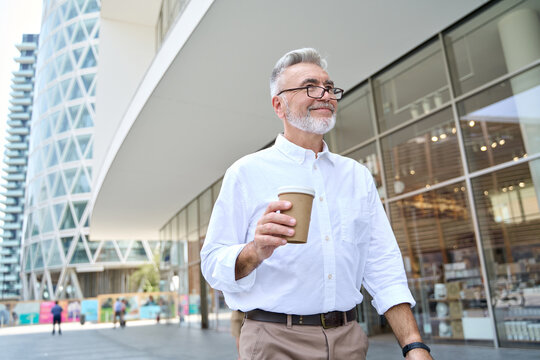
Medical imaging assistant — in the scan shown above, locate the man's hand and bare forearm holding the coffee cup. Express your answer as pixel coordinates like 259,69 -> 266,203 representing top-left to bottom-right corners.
235,201 -> 296,280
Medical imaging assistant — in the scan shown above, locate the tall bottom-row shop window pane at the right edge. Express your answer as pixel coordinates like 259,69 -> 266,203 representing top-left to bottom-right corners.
472,160 -> 540,346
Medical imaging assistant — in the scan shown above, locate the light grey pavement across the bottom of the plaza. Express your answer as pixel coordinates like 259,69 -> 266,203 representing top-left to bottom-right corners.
0,321 -> 540,360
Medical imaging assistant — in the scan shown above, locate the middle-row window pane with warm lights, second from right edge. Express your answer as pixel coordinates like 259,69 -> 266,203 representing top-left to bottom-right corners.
381,108 -> 463,196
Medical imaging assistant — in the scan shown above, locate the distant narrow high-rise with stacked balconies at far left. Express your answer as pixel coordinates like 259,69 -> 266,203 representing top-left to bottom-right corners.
0,34 -> 39,299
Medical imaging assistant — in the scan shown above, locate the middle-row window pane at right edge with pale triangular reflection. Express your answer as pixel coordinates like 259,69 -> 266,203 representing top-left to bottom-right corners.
458,68 -> 540,171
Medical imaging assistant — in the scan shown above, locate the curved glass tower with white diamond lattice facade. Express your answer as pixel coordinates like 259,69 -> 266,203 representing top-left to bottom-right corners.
22,0 -> 152,299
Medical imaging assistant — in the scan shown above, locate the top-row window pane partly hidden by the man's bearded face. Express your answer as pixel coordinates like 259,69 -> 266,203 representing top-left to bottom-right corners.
325,85 -> 375,153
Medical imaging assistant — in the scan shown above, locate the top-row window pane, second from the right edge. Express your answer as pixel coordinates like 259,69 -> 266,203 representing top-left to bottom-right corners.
373,42 -> 450,132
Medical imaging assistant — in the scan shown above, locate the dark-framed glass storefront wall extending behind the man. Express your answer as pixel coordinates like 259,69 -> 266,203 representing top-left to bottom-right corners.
161,0 -> 540,347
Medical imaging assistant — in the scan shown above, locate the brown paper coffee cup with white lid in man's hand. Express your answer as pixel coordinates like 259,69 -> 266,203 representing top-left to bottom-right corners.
278,186 -> 315,244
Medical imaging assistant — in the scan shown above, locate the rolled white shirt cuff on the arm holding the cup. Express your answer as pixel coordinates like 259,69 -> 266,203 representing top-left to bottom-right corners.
212,244 -> 257,292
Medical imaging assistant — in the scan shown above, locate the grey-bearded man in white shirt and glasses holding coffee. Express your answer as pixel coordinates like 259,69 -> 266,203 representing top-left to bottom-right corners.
201,48 -> 431,360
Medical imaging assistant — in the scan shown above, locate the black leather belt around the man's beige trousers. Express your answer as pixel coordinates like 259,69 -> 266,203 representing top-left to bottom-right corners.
246,307 -> 356,329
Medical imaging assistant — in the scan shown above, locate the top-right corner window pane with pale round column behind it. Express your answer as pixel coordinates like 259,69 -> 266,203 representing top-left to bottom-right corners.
444,0 -> 540,96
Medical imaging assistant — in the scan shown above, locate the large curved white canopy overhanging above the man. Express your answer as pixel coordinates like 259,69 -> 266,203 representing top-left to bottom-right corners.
91,0 -> 486,239
